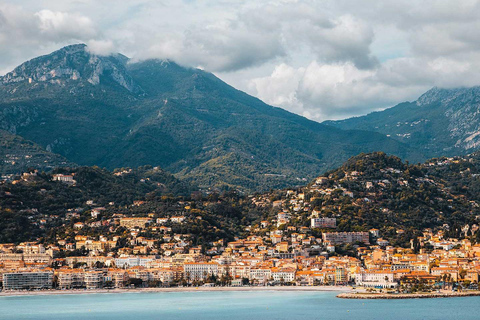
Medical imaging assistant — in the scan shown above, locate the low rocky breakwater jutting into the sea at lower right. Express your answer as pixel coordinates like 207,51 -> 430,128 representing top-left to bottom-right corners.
337,291 -> 480,300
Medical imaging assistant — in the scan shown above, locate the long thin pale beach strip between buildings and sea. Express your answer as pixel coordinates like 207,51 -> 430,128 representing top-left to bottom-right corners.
0,286 -> 352,297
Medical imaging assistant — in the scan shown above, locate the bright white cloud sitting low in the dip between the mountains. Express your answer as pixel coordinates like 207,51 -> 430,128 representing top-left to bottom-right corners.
249,61 -> 433,121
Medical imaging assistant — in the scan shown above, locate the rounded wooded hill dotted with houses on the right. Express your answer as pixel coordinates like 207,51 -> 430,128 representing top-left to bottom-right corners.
312,153 -> 480,245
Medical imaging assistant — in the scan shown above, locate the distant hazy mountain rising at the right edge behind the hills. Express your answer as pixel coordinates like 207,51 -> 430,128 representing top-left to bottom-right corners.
325,87 -> 480,157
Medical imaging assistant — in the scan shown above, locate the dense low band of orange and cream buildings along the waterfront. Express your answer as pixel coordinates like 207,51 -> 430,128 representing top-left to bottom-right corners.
0,225 -> 480,290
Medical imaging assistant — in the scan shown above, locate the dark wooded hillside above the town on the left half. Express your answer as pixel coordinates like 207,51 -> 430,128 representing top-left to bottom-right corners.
0,166 -> 258,245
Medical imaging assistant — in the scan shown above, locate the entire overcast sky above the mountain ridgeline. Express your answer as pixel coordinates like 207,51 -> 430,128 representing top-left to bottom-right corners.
0,0 -> 480,121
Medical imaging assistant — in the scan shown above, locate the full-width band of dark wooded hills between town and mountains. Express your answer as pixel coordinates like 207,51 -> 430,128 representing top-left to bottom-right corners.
0,153 -> 480,250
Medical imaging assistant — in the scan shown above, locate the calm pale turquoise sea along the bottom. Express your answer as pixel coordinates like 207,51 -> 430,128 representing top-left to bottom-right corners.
0,292 -> 480,320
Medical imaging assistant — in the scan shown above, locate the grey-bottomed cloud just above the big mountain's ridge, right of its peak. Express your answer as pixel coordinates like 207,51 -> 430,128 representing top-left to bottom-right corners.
131,21 -> 285,71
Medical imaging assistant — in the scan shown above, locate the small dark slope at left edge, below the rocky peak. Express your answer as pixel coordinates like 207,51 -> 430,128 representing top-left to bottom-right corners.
0,130 -> 75,175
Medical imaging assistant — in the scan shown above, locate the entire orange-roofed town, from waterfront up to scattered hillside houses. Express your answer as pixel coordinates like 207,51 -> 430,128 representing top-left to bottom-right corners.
0,156 -> 480,293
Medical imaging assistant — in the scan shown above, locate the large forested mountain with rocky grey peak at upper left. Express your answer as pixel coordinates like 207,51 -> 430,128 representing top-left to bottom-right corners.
0,45 -> 424,191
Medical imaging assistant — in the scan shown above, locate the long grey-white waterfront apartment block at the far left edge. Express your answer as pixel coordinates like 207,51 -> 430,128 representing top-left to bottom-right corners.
3,271 -> 53,290
